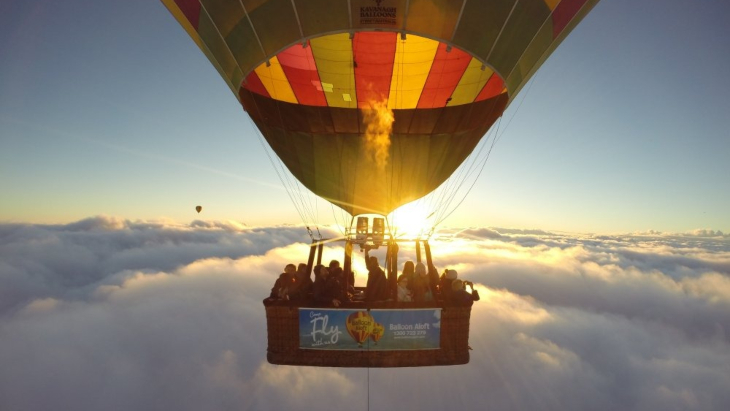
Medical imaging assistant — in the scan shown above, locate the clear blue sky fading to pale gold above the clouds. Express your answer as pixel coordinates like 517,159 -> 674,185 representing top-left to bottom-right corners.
0,0 -> 730,233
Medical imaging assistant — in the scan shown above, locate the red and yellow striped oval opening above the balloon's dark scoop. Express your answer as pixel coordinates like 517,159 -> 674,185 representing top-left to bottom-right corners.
241,31 -> 507,110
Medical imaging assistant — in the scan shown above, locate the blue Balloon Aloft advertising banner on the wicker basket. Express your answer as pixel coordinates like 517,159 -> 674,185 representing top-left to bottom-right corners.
299,308 -> 441,351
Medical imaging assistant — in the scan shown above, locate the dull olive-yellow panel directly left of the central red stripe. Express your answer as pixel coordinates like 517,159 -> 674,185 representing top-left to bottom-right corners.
309,33 -> 357,108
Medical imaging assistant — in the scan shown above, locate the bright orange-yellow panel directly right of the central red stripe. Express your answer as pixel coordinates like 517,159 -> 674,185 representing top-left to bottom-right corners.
388,36 -> 439,109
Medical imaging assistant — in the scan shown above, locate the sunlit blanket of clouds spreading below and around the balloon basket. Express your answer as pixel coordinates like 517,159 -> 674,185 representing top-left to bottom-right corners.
0,217 -> 730,410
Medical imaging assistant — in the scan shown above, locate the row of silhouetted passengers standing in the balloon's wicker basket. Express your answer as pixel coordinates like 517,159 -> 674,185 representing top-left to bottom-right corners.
269,251 -> 479,307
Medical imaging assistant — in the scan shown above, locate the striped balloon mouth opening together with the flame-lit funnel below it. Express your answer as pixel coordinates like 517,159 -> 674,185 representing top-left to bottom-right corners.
239,31 -> 509,219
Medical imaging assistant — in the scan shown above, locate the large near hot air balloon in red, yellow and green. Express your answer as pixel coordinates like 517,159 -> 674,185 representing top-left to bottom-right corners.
162,0 -> 598,366
